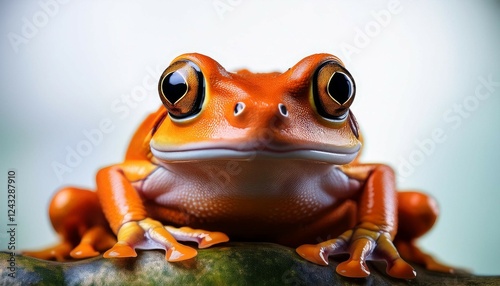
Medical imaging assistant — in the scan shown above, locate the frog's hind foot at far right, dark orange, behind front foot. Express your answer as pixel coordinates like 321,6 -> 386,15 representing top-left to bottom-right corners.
394,240 -> 458,273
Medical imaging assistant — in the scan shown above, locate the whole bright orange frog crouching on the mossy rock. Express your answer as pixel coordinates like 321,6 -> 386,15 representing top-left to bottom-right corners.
27,54 -> 452,279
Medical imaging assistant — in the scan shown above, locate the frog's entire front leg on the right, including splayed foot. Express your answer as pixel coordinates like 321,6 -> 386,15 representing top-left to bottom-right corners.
297,165 -> 416,279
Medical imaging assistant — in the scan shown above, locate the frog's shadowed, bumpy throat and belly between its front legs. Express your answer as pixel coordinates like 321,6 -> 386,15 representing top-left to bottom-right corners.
138,160 -> 360,237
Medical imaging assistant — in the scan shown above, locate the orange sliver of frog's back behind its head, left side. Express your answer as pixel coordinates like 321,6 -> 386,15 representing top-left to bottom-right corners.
125,106 -> 167,160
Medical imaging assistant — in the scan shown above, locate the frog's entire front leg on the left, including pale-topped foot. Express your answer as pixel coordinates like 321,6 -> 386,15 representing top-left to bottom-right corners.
97,161 -> 228,261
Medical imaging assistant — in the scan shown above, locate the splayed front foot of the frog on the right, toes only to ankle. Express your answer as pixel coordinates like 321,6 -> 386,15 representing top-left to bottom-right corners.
297,225 -> 416,279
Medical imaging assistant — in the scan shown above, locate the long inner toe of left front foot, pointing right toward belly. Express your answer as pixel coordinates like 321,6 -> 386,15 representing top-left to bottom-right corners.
165,226 -> 229,248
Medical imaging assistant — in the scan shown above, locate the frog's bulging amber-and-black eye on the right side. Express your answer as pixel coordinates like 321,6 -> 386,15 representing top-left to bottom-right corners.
313,61 -> 356,120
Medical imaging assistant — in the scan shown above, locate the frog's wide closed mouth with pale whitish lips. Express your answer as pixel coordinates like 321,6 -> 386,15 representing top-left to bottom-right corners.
151,141 -> 361,165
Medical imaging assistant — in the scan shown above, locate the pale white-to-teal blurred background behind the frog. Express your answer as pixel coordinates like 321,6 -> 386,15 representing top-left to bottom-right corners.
0,0 -> 500,275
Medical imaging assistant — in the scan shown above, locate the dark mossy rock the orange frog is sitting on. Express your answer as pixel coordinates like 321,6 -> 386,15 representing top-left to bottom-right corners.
0,243 -> 500,285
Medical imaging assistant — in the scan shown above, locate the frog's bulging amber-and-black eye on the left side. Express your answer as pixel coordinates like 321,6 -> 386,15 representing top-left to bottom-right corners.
158,61 -> 205,119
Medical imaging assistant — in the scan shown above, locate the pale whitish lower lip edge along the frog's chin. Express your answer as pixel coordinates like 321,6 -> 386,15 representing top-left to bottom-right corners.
151,146 -> 360,165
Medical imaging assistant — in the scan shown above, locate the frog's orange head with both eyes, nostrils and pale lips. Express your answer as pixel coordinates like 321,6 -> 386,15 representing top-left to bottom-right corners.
150,54 -> 361,164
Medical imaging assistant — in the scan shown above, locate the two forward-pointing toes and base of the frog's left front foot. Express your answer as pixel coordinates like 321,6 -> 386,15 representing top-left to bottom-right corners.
104,218 -> 207,262
